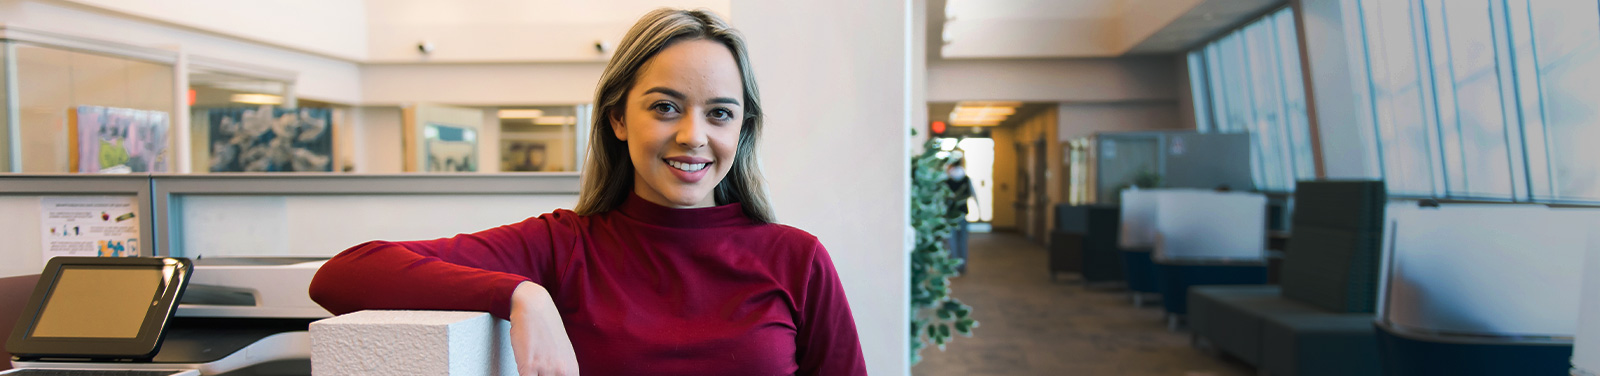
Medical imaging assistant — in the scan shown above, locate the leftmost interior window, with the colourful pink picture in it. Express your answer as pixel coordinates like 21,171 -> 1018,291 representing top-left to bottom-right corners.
5,42 -> 174,173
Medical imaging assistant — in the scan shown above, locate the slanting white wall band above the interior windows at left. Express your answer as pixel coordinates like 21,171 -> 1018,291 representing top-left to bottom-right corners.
0,0 -> 362,104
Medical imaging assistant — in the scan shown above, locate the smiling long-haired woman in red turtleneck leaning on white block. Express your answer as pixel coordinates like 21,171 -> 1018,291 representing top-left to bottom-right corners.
310,10 -> 866,374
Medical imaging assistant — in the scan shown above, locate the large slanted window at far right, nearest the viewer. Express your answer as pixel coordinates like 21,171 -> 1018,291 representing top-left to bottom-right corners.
1349,0 -> 1600,202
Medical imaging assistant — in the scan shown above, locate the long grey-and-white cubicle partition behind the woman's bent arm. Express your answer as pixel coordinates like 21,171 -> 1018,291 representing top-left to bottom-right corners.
0,173 -> 578,270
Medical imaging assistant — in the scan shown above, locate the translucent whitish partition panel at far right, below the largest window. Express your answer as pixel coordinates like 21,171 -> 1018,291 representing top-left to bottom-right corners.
1379,205 -> 1600,338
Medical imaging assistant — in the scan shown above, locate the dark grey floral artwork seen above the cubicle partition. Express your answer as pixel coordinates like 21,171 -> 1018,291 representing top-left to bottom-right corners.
210,106 -> 333,173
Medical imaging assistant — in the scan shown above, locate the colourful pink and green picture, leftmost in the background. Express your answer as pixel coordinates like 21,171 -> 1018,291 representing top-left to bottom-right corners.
67,106 -> 171,173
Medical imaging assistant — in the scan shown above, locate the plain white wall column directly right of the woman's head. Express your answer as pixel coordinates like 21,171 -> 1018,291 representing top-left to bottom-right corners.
733,0 -> 922,374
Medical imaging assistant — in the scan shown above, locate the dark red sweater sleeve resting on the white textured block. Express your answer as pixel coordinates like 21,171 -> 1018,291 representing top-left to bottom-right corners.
310,214 -> 558,318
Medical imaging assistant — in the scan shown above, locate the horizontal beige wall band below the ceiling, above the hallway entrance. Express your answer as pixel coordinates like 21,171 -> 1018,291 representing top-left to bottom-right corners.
928,58 -> 1184,102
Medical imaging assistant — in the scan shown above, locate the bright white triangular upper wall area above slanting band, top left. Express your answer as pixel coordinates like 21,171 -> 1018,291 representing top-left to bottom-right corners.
67,0 -> 366,61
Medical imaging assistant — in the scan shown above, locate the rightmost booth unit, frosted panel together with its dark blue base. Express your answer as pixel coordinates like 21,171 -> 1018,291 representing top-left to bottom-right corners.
1376,205 -> 1600,374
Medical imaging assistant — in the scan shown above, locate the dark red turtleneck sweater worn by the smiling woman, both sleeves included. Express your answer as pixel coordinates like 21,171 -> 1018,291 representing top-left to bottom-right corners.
310,195 -> 866,374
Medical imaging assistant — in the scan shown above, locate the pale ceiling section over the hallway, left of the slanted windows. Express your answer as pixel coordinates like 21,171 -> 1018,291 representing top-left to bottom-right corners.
928,0 -> 1285,59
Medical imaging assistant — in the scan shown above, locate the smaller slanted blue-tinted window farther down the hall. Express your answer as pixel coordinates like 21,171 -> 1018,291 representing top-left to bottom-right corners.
1189,8 -> 1315,192
